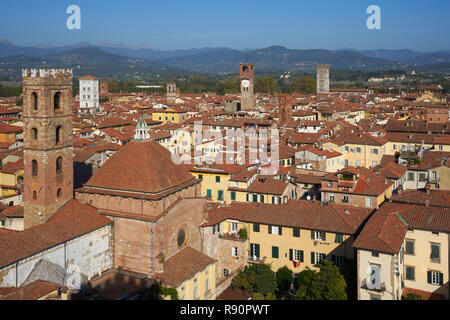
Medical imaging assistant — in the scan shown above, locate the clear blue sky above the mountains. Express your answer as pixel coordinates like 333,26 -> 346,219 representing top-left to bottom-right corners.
0,0 -> 450,51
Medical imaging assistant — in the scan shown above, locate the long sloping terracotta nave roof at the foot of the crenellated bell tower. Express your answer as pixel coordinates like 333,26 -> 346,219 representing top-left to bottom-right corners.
0,200 -> 112,268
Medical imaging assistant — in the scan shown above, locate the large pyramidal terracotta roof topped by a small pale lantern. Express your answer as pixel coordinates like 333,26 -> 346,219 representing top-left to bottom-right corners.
85,141 -> 194,193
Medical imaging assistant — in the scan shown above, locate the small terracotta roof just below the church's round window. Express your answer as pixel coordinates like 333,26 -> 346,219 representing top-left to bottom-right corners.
160,247 -> 217,287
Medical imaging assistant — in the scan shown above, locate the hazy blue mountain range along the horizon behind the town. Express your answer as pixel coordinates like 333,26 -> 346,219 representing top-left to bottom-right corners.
0,40 -> 450,79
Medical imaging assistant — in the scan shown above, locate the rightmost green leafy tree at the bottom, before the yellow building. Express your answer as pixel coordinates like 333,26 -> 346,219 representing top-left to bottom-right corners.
297,259 -> 347,300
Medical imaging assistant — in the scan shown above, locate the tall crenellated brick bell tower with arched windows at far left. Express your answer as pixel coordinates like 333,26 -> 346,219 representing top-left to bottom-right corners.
22,69 -> 73,228
